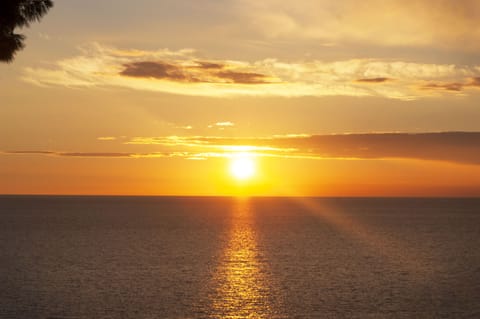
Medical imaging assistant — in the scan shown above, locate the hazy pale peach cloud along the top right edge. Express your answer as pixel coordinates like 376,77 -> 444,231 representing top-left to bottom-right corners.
235,0 -> 480,51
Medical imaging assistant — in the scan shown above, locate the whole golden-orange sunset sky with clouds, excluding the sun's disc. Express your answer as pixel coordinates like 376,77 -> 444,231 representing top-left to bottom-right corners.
0,0 -> 480,196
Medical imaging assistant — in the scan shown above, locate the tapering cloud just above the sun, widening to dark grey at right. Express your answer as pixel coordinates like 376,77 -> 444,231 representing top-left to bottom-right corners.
127,132 -> 480,164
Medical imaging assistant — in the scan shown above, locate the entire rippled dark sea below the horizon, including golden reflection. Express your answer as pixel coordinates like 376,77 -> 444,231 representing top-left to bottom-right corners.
0,196 -> 480,319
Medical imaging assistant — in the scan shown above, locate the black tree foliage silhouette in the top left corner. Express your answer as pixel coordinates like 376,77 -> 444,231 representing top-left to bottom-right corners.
0,0 -> 53,62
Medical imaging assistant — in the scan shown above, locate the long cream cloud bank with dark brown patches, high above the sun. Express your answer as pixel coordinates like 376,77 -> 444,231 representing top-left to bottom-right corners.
23,44 -> 480,100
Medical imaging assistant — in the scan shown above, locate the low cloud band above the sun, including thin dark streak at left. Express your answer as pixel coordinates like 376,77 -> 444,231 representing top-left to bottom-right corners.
3,132 -> 480,165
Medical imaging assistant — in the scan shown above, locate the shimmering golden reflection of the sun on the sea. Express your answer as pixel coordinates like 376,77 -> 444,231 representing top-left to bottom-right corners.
212,198 -> 275,319
